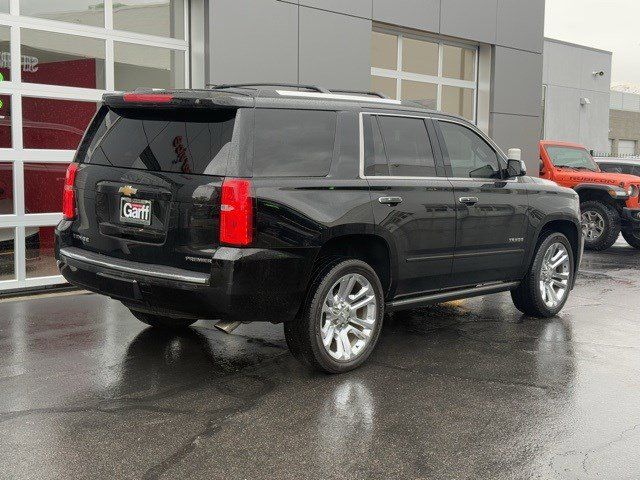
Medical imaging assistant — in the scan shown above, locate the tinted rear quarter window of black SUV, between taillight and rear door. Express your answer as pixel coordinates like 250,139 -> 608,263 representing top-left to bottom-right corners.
253,109 -> 337,177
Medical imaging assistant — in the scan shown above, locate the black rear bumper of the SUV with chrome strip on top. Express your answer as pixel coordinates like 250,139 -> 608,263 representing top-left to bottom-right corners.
56,236 -> 316,323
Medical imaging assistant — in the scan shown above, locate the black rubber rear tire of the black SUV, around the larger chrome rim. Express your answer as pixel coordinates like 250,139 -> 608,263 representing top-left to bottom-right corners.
284,259 -> 384,373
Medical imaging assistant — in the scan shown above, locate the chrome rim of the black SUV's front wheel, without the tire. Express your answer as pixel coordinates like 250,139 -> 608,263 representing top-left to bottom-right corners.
540,242 -> 571,309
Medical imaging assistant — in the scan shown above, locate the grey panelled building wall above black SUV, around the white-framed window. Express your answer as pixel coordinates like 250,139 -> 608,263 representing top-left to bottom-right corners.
206,0 -> 544,172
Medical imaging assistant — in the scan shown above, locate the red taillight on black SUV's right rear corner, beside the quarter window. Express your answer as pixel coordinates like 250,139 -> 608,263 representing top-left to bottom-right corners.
220,178 -> 253,246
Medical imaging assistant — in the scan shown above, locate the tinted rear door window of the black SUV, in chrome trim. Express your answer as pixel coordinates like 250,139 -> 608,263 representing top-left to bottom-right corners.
378,116 -> 436,177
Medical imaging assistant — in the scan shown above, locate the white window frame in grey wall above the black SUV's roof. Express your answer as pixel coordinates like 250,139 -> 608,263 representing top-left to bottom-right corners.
371,25 -> 480,124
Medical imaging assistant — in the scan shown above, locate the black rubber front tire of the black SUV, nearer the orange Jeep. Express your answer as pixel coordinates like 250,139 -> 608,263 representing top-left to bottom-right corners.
511,232 -> 575,318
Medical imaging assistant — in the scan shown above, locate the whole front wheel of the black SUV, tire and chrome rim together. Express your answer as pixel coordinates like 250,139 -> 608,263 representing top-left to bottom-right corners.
511,233 -> 574,318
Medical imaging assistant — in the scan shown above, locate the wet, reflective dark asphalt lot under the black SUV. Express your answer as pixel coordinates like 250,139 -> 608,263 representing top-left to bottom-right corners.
0,238 -> 640,480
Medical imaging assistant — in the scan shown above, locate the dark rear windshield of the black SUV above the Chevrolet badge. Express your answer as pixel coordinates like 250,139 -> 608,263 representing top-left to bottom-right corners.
78,107 -> 236,175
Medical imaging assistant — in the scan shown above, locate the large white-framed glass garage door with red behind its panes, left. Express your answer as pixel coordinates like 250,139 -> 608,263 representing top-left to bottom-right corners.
0,0 -> 189,291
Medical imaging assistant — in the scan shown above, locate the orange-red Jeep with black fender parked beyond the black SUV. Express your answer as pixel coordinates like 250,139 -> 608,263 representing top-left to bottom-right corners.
540,140 -> 640,250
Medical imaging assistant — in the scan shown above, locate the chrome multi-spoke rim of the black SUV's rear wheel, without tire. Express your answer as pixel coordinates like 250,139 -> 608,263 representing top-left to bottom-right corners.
320,273 -> 378,361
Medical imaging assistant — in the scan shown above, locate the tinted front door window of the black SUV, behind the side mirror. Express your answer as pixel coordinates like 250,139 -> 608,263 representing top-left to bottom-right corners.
438,121 -> 501,178
